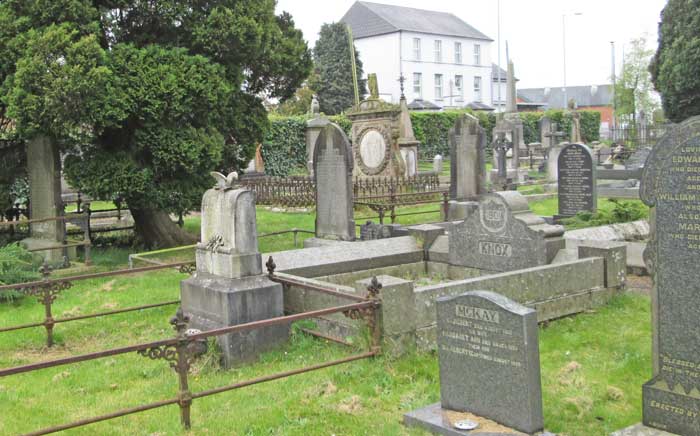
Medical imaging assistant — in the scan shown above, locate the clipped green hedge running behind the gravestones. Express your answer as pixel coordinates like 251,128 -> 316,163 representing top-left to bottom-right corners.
262,110 -> 600,176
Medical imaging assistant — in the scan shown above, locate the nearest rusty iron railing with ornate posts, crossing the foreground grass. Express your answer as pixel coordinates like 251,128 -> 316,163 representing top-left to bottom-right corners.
0,258 -> 381,435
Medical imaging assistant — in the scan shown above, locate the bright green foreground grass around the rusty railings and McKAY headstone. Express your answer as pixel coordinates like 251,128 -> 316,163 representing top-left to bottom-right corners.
0,256 -> 651,436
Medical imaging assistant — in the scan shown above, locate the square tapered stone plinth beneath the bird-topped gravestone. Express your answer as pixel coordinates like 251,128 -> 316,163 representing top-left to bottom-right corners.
180,272 -> 289,368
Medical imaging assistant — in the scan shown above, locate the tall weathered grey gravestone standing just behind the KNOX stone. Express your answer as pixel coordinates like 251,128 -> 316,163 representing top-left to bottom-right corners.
449,114 -> 486,201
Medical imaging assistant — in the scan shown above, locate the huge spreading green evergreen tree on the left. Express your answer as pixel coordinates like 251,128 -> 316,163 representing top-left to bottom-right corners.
0,0 -> 312,246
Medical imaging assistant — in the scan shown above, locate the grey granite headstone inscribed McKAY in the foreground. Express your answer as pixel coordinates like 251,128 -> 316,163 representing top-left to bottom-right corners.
437,291 -> 544,433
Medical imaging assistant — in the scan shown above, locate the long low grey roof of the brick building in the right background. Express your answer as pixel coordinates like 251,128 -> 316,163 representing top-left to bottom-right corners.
518,85 -> 612,109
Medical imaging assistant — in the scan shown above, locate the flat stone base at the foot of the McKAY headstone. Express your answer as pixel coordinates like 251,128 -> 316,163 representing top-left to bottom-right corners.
403,403 -> 555,436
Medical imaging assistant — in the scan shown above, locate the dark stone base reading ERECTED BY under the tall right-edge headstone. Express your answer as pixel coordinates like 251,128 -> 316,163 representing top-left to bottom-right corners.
642,378 -> 700,436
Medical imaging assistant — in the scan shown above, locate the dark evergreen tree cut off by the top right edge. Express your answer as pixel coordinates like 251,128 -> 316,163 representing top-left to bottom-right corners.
650,0 -> 700,122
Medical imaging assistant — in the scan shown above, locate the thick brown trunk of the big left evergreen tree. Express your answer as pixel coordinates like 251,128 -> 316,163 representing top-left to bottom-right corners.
129,208 -> 197,248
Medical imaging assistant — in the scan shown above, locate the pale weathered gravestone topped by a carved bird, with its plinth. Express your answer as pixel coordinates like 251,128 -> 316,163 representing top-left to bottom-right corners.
180,173 -> 289,367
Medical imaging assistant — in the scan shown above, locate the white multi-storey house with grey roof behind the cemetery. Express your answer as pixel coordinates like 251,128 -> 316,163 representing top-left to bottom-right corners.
341,1 -> 494,110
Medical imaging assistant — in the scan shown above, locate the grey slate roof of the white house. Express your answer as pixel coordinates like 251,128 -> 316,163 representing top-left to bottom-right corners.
340,1 -> 492,41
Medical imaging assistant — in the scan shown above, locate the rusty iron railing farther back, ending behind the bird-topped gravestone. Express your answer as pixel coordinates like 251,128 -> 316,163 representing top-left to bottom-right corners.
0,262 -> 194,347
